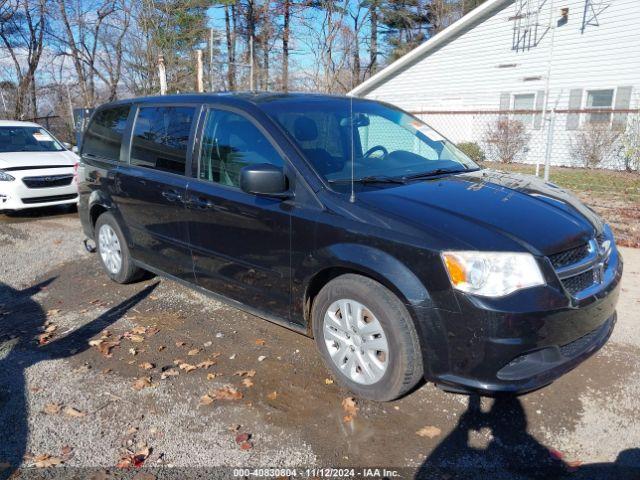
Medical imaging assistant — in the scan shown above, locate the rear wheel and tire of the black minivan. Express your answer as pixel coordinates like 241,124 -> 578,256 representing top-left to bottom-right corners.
95,212 -> 144,283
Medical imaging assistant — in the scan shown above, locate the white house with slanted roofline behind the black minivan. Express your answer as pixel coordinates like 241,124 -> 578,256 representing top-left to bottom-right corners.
350,0 -> 640,172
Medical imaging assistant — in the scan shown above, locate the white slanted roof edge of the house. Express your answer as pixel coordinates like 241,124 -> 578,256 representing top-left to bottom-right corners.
348,0 -> 514,96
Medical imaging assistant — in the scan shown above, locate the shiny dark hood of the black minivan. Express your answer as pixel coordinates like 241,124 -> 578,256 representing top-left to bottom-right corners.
358,170 -> 603,255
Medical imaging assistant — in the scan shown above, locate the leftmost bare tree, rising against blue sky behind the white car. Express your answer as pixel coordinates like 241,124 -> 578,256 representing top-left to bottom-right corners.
0,0 -> 46,119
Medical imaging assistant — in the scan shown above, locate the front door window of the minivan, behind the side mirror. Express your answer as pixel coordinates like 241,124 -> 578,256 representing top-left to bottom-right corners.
198,109 -> 283,187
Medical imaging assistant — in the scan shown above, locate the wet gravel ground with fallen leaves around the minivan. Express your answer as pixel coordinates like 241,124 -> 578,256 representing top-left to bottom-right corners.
0,212 -> 640,479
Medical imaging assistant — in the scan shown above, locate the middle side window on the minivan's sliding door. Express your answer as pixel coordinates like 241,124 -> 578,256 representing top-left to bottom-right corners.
131,107 -> 195,175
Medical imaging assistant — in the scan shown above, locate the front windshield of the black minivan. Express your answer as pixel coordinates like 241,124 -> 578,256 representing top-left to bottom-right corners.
260,97 -> 479,183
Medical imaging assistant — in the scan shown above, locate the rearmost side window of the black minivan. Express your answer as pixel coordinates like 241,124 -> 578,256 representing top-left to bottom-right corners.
82,105 -> 131,161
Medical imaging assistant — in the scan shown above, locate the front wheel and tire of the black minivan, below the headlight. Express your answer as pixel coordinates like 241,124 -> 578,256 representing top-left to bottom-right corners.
312,274 -> 423,401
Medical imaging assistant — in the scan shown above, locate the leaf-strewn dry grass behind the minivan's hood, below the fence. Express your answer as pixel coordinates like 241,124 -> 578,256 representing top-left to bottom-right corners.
484,162 -> 640,248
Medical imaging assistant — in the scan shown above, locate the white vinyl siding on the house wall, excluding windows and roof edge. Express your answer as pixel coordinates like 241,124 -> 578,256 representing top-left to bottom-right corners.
362,0 -> 640,169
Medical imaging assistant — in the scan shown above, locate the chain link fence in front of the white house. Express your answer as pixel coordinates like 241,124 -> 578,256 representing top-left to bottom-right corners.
412,109 -> 640,172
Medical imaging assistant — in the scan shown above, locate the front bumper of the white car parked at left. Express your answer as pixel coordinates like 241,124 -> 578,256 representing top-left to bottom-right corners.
0,167 -> 78,211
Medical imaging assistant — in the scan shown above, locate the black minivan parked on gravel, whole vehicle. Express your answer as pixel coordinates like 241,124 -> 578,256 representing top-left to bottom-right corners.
79,93 -> 622,400
